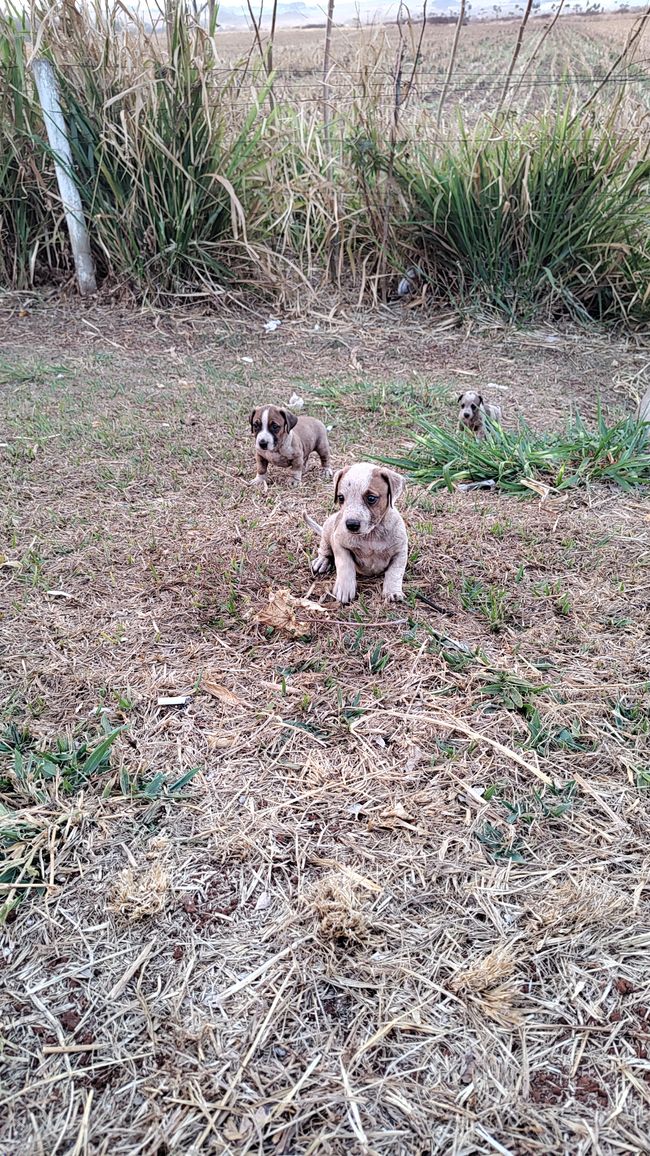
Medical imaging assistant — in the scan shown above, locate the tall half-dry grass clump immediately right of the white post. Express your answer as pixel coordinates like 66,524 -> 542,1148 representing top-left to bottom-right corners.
49,5 -> 268,298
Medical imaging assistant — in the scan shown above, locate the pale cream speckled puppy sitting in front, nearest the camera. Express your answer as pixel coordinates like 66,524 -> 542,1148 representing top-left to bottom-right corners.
305,461 -> 408,605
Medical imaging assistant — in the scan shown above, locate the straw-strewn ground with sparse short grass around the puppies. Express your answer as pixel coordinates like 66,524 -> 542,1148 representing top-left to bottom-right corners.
0,305 -> 650,1156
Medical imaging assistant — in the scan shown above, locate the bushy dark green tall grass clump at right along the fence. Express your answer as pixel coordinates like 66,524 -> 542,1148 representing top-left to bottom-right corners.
386,109 -> 650,323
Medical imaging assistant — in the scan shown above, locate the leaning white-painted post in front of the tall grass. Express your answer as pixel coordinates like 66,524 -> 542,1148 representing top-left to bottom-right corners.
31,58 -> 97,297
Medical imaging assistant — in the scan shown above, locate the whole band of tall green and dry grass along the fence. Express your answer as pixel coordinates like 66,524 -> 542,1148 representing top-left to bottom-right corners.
0,0 -> 650,324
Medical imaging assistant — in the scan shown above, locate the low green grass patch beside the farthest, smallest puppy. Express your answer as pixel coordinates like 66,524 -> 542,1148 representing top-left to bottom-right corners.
385,414 -> 650,497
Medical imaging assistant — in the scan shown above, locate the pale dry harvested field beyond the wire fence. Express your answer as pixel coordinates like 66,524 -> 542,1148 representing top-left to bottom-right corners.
217,12 -> 650,139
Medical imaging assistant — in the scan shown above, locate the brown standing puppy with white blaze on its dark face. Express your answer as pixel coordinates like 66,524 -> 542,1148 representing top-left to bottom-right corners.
251,406 -> 332,492
